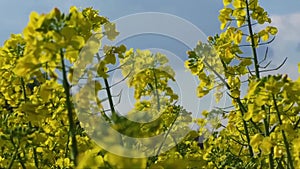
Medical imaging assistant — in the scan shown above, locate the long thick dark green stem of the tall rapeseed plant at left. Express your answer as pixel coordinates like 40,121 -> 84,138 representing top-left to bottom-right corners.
60,50 -> 78,166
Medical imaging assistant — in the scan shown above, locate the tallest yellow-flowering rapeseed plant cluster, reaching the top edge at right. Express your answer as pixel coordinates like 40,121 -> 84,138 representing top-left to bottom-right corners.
186,0 -> 299,168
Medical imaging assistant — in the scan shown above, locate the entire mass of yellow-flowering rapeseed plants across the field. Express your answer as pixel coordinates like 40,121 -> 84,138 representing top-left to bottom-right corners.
0,0 -> 300,169
